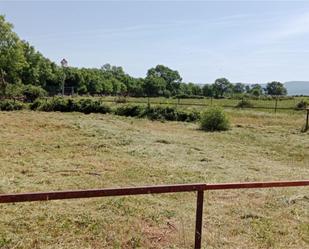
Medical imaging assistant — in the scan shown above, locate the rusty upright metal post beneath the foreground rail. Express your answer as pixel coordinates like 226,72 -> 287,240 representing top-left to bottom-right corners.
194,191 -> 204,249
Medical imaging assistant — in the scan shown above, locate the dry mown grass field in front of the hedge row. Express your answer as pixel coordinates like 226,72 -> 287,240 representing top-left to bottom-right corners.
0,110 -> 309,249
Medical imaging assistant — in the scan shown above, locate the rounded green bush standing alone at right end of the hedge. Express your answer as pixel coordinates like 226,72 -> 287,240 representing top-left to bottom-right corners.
201,108 -> 230,131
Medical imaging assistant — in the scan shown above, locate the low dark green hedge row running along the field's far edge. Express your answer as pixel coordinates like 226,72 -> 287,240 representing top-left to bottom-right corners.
30,98 -> 200,122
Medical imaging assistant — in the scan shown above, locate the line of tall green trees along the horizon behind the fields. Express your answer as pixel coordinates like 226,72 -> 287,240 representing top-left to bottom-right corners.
0,15 -> 287,98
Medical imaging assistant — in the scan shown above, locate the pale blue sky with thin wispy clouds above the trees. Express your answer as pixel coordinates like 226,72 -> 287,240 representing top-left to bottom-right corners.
0,0 -> 309,83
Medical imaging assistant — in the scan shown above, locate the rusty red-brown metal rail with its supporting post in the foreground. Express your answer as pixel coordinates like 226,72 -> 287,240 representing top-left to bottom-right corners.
0,180 -> 309,249
